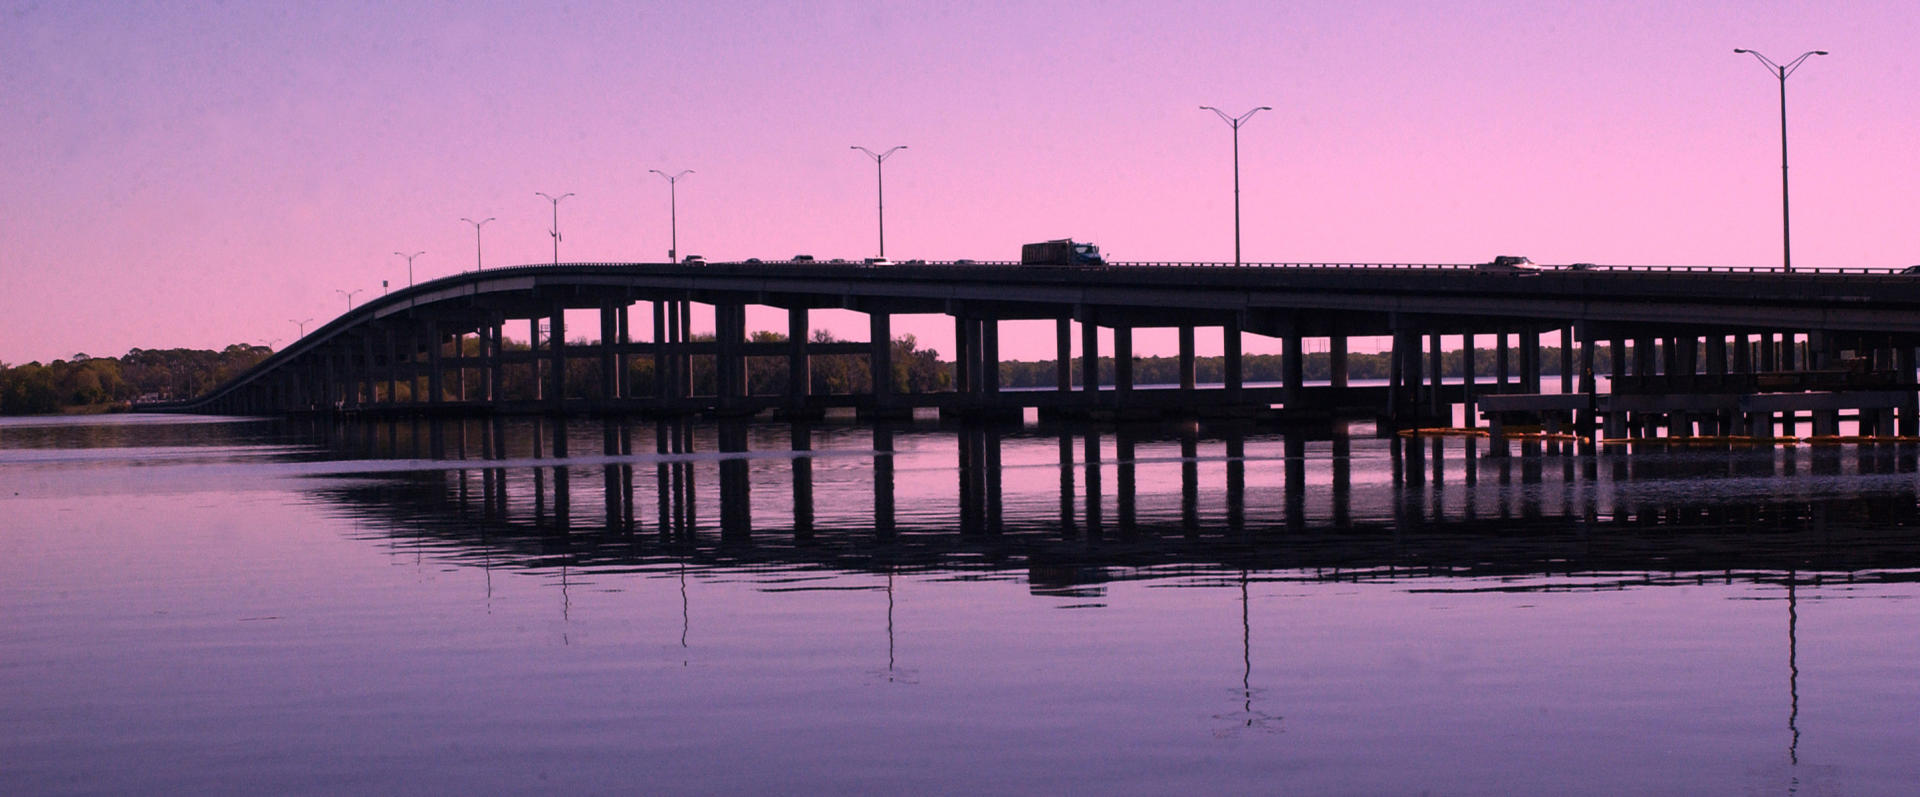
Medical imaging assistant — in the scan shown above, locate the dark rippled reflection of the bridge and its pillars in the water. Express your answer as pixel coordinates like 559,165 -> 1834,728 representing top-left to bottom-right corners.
305,419 -> 1920,592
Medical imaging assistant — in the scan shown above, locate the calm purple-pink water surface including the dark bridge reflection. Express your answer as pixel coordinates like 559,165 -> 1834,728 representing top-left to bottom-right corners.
0,417 -> 1920,795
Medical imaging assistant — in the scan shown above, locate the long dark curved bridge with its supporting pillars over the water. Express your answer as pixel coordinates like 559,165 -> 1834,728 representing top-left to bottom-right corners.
171,261 -> 1920,434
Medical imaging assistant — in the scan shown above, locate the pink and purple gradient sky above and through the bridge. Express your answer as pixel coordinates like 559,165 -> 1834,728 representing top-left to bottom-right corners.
0,0 -> 1920,365
